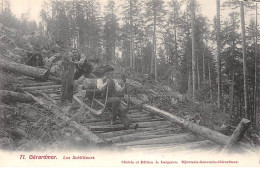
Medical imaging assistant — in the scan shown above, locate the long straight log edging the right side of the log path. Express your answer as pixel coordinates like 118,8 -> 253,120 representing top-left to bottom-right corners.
131,98 -> 251,149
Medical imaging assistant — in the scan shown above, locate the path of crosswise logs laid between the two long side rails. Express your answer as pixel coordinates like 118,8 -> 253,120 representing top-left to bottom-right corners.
19,80 -> 220,153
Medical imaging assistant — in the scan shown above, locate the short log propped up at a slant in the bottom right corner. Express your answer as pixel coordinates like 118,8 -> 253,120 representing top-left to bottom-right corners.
221,119 -> 250,153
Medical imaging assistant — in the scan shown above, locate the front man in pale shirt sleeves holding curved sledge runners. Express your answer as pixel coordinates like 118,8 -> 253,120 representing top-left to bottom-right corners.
97,66 -> 131,129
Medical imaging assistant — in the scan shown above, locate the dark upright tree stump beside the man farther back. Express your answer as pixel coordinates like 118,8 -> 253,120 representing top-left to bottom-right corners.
60,56 -> 74,102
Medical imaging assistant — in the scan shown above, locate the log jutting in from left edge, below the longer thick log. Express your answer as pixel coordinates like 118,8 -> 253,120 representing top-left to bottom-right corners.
0,90 -> 34,103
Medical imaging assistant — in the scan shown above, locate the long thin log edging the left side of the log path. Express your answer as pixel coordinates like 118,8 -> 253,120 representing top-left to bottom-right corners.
27,93 -> 108,145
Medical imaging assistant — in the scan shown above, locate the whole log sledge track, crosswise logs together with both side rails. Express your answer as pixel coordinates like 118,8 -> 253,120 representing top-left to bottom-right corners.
9,80 -> 252,154
